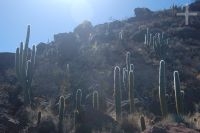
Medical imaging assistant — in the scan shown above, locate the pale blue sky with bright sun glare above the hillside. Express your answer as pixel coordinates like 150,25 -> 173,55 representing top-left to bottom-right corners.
0,0 -> 191,52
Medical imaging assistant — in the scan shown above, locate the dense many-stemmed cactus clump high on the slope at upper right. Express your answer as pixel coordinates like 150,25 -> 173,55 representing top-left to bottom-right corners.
144,28 -> 169,59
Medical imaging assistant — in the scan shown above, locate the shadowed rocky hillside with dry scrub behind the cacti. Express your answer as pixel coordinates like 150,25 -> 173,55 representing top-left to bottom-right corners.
0,2 -> 200,133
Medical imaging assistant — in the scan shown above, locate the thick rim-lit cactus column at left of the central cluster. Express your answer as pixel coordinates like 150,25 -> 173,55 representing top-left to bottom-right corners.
114,66 -> 121,120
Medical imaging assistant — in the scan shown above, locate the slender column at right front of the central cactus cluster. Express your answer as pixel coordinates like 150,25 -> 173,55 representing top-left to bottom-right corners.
128,70 -> 134,113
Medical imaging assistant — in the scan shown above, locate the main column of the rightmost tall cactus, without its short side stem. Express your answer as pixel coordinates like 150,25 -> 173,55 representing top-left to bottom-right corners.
174,71 -> 183,115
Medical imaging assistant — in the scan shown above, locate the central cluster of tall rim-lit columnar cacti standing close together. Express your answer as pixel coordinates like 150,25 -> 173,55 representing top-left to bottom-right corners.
114,52 -> 134,120
